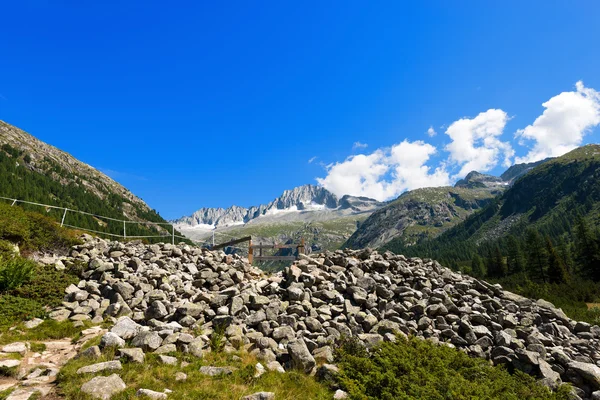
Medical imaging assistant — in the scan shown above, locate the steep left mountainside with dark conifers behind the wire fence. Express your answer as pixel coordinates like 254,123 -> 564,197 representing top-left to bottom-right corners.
0,121 -> 180,241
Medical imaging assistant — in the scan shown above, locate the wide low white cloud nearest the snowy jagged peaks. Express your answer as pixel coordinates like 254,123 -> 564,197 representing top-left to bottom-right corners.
317,140 -> 450,200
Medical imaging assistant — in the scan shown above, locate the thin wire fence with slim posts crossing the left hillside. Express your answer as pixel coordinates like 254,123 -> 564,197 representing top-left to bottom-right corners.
0,196 -> 195,244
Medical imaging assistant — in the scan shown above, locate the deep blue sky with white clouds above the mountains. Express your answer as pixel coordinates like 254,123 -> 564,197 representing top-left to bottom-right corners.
0,0 -> 600,218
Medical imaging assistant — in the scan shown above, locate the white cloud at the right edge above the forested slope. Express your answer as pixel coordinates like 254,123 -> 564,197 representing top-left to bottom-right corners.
515,81 -> 600,163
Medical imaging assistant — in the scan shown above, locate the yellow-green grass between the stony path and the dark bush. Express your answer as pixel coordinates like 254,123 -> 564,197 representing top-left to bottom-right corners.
58,351 -> 333,400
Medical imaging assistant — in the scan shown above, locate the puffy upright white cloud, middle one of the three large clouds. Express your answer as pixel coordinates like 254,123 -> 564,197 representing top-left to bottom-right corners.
445,109 -> 514,178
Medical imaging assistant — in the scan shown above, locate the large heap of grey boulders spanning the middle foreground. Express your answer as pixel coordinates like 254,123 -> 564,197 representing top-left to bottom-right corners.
39,237 -> 600,398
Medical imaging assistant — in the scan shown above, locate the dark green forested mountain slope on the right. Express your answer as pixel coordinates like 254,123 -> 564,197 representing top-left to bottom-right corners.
383,145 -> 600,262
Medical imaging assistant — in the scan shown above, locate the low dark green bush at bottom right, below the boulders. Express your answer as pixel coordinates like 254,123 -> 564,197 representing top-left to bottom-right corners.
338,336 -> 569,400
